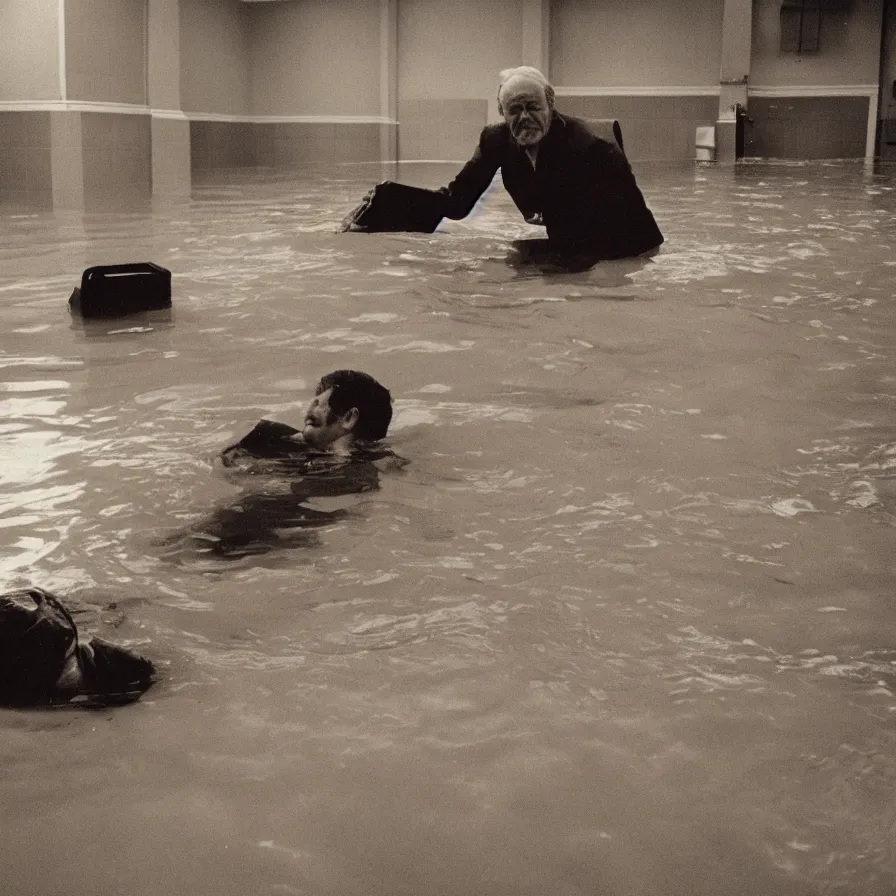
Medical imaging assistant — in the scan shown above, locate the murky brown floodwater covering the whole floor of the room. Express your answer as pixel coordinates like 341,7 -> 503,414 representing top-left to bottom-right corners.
0,164 -> 896,896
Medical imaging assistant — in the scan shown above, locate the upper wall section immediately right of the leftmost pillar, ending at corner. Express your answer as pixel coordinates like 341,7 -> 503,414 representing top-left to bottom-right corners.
180,0 -> 253,115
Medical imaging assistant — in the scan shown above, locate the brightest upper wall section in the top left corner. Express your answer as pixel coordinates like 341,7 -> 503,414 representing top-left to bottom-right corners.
0,0 -> 61,101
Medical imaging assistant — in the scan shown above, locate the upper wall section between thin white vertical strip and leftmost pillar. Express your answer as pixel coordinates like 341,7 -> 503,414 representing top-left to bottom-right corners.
65,0 -> 146,106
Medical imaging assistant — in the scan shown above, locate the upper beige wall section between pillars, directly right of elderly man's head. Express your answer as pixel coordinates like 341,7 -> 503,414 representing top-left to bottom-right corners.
550,0 -> 724,87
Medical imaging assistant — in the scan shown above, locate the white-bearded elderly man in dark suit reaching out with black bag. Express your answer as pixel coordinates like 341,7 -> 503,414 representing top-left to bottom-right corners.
344,66 -> 663,260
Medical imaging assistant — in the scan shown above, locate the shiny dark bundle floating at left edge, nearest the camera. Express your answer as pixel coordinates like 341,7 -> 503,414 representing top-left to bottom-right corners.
0,588 -> 155,707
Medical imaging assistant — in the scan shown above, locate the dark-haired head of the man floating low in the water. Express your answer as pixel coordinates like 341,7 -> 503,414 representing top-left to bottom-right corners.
302,370 -> 392,451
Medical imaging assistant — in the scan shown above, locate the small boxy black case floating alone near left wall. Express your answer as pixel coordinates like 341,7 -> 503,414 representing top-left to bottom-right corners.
69,262 -> 171,317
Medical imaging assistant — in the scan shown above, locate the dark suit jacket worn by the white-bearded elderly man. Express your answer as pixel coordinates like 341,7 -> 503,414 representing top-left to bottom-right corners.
440,112 -> 663,258
